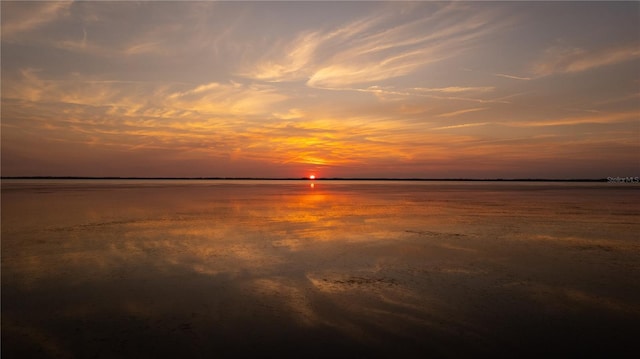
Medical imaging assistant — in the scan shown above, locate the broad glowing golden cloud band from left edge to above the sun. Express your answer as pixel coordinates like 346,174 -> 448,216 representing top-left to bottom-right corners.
3,69 -> 484,173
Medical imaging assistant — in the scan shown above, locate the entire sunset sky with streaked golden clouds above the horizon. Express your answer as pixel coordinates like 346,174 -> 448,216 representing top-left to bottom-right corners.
1,1 -> 640,178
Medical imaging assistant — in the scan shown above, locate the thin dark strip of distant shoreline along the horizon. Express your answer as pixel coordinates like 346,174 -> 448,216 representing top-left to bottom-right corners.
0,176 -> 608,182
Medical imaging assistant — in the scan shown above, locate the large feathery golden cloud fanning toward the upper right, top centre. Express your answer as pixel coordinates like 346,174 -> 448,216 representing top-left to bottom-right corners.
238,4 -> 508,90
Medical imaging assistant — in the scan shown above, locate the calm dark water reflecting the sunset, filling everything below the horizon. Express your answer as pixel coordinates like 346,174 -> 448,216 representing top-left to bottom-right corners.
1,180 -> 640,358
